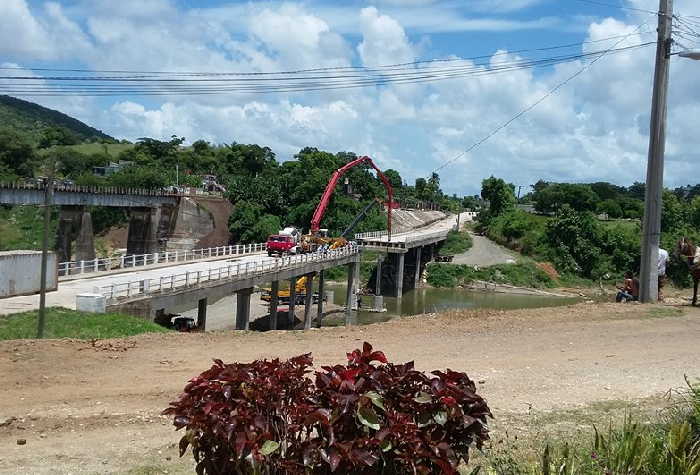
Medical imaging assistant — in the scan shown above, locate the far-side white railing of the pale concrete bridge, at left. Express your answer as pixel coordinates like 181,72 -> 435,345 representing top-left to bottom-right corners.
58,242 -> 265,277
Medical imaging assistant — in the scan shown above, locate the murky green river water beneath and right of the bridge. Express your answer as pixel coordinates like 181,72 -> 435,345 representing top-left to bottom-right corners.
324,284 -> 579,325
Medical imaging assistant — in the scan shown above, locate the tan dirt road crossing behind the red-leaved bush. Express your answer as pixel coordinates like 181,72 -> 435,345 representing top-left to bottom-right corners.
0,303 -> 700,474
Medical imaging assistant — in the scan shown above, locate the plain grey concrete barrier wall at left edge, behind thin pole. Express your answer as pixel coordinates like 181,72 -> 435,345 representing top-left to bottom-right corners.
0,251 -> 58,298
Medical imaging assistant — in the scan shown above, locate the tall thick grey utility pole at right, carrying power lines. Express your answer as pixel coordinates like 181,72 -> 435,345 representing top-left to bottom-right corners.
639,0 -> 673,303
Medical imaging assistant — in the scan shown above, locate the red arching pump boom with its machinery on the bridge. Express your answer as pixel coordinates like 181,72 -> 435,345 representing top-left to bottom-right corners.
301,156 -> 394,252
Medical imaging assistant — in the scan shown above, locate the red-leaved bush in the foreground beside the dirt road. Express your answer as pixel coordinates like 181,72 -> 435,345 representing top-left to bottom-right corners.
163,343 -> 491,475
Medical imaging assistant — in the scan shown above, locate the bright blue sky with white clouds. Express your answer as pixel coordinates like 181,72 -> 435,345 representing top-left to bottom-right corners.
0,0 -> 700,195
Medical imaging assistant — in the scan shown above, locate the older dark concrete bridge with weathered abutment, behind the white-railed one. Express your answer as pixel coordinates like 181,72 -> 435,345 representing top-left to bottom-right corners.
0,183 -> 232,262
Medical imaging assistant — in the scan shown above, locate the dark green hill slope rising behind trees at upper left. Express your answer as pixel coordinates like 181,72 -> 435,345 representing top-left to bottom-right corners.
0,95 -> 115,144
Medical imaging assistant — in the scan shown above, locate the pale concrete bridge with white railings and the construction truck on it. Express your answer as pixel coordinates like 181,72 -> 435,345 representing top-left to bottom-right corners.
0,212 -> 470,330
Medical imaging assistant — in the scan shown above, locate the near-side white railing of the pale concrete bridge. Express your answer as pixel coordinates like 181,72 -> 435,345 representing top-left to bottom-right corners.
99,245 -> 359,301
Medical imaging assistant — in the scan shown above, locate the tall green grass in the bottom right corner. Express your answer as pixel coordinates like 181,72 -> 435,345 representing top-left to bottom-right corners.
476,381 -> 700,475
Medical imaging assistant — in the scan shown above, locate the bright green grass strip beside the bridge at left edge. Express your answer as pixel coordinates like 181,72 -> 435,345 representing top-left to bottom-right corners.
0,307 -> 170,340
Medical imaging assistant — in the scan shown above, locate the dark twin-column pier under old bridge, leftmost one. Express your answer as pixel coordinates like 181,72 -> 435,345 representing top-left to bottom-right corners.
56,206 -> 95,262
